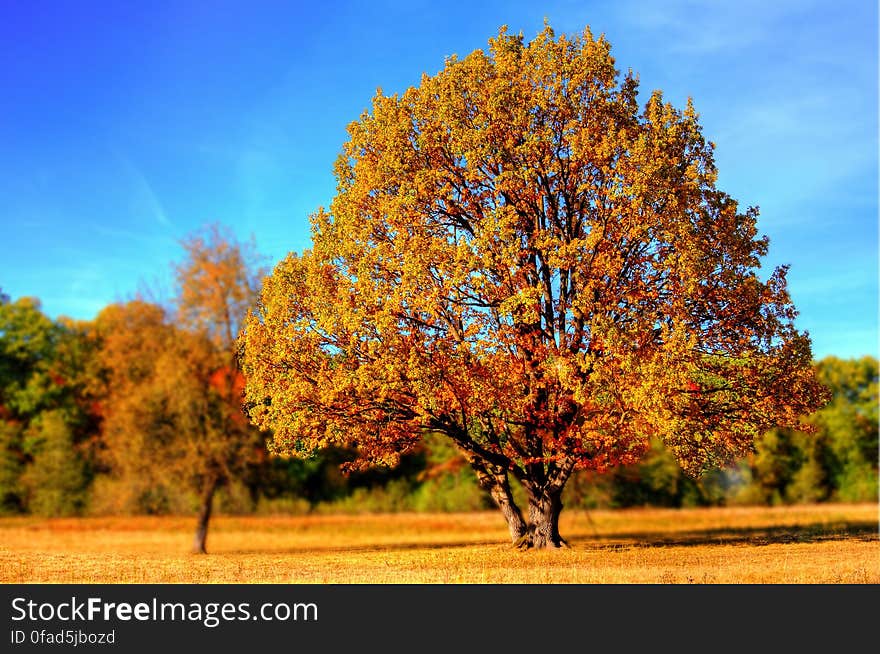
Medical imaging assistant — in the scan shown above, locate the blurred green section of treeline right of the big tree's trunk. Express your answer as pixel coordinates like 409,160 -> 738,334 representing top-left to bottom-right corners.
568,356 -> 880,507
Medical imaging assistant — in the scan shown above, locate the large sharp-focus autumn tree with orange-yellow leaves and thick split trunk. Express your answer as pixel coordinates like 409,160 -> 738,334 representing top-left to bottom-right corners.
243,27 -> 823,547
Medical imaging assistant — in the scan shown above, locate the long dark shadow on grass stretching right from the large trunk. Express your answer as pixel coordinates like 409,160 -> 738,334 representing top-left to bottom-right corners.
569,522 -> 878,548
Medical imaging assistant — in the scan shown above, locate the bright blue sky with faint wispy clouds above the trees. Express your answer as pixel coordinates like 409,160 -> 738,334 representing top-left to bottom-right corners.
0,0 -> 878,357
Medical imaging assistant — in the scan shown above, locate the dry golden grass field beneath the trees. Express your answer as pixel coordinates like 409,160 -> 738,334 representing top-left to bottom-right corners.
0,504 -> 880,584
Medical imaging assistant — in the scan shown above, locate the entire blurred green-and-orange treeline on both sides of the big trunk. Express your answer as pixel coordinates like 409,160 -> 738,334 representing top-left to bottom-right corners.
0,226 -> 878,524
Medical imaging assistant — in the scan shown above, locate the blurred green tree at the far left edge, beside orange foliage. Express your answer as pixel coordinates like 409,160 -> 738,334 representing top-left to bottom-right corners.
0,298 -> 97,515
